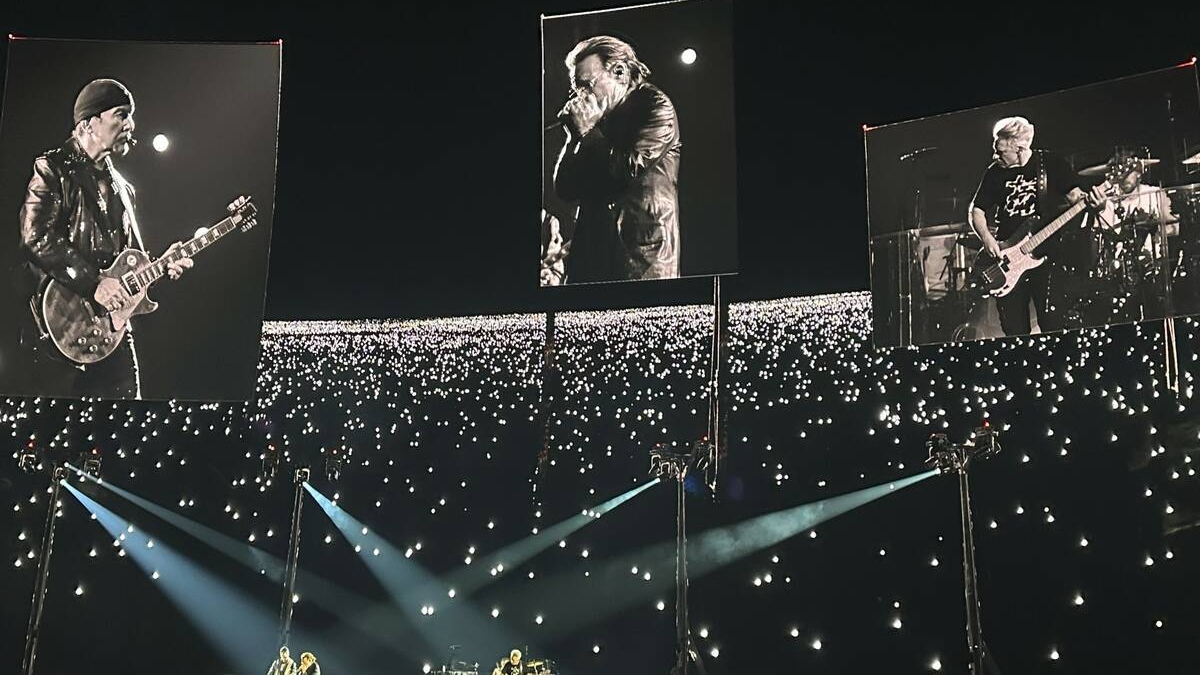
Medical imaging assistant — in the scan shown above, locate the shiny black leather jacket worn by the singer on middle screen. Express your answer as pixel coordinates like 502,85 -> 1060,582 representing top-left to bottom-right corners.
554,83 -> 682,283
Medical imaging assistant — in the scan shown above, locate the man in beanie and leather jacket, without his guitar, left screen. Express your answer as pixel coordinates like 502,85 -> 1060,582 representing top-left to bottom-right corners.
20,79 -> 192,399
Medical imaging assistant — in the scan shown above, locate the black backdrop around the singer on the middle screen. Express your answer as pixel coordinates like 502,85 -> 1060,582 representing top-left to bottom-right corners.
542,0 -> 738,282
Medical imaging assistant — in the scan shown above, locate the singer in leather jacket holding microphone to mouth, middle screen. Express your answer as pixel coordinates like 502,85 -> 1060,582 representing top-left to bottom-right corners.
554,36 -> 682,283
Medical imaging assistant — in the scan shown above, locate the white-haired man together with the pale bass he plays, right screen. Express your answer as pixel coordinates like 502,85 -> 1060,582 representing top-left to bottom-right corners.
967,117 -> 1106,335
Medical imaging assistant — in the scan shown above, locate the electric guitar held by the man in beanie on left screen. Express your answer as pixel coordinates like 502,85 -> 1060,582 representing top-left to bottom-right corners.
34,197 -> 256,364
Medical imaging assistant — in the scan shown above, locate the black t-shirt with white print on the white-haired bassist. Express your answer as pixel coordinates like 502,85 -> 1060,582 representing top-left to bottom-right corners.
972,150 -> 1080,240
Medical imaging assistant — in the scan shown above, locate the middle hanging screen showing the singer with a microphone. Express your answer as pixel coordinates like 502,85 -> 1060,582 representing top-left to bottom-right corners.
539,0 -> 738,286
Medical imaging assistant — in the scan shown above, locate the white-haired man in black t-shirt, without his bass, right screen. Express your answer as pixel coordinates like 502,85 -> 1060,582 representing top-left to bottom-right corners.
968,117 -> 1106,335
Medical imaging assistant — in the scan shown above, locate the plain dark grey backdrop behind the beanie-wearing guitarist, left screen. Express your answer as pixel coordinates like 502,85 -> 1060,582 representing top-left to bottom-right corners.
0,40 -> 280,400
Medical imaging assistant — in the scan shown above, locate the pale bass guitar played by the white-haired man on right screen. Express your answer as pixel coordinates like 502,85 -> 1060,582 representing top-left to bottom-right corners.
972,157 -> 1142,298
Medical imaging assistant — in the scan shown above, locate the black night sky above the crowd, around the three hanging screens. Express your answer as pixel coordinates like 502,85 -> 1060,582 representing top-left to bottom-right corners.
0,0 -> 1198,319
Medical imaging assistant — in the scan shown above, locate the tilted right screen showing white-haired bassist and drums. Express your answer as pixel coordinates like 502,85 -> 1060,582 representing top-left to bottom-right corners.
865,61 -> 1200,347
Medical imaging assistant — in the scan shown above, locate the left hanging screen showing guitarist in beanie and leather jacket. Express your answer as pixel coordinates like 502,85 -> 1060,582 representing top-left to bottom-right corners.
0,37 -> 281,401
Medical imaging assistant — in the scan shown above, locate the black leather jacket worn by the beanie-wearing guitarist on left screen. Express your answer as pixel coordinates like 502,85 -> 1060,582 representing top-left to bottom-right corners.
20,139 -> 132,298
